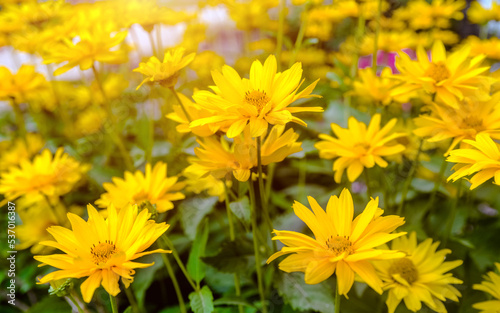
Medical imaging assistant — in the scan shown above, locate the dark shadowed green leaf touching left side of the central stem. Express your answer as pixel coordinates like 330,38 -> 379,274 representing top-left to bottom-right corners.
202,239 -> 254,273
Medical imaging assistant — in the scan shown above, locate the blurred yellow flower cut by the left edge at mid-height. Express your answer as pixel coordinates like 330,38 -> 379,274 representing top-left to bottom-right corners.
0,148 -> 90,200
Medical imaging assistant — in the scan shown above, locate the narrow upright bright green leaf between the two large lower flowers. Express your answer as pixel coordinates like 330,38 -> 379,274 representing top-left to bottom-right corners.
187,219 -> 209,284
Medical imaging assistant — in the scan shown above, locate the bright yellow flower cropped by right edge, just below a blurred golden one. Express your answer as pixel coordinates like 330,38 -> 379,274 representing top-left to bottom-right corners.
446,134 -> 500,190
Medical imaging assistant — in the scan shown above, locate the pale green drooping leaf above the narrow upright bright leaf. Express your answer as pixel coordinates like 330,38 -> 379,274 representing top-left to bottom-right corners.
178,197 -> 219,240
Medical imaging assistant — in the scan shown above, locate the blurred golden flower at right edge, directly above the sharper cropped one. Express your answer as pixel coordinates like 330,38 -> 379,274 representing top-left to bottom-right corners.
414,92 -> 500,153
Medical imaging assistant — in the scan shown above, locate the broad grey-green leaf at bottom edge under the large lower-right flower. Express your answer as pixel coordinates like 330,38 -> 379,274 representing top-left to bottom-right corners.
278,273 -> 335,313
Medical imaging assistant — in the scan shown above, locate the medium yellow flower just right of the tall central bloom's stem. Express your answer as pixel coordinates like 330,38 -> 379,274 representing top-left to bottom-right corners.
314,114 -> 405,183
